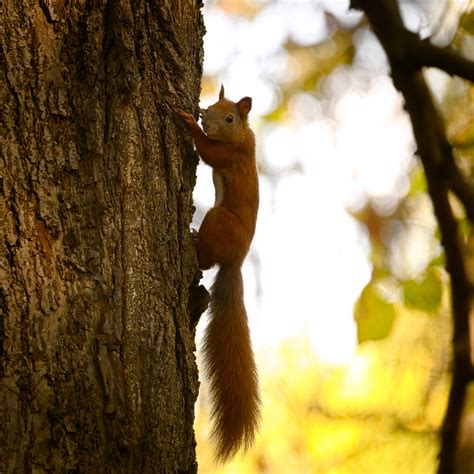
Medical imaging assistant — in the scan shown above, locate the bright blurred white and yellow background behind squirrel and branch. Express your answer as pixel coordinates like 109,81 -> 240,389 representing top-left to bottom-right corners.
193,0 -> 474,474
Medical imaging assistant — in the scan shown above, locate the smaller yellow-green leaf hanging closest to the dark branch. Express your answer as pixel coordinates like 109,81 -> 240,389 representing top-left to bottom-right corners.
402,269 -> 443,313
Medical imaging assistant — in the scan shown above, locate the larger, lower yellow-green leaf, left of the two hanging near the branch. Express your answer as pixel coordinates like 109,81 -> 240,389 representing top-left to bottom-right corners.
354,282 -> 396,344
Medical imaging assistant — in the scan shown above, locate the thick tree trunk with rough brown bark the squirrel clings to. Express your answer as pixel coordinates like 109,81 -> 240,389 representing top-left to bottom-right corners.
0,0 -> 204,473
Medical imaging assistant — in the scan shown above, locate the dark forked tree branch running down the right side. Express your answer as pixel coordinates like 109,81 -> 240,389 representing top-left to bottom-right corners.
351,0 -> 474,474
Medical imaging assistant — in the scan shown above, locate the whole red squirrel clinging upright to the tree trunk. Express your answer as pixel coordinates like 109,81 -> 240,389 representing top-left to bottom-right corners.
179,86 -> 260,461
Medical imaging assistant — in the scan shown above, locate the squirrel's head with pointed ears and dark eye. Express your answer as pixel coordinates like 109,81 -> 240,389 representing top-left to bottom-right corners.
200,85 -> 252,142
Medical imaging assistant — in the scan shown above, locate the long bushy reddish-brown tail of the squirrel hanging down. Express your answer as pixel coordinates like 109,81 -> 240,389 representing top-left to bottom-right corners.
203,266 -> 260,462
